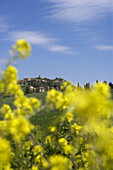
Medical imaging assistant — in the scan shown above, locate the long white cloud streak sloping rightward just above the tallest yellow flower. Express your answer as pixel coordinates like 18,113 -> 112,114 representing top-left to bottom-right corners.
5,31 -> 75,54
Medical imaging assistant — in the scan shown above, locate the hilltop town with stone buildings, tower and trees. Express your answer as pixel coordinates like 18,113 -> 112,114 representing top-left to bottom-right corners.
18,75 -> 66,93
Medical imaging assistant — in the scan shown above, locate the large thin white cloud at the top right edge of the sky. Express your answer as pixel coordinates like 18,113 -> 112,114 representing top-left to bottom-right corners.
46,0 -> 113,23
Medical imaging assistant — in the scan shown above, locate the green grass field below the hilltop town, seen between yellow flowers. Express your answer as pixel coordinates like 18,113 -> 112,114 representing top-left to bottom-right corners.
0,93 -> 59,134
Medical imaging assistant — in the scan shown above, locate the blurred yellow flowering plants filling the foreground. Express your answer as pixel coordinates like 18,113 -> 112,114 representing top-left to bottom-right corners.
0,40 -> 113,170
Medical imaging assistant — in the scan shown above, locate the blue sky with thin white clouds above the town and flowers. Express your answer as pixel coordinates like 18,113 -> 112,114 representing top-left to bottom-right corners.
0,0 -> 113,84
